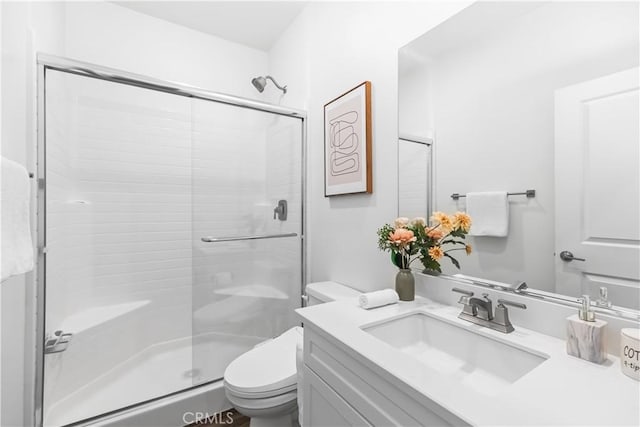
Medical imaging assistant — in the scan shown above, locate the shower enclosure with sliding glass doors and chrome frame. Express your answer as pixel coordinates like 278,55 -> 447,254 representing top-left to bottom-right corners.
36,56 -> 305,426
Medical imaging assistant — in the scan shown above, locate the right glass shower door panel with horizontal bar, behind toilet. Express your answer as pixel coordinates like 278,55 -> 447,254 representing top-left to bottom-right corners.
192,100 -> 302,384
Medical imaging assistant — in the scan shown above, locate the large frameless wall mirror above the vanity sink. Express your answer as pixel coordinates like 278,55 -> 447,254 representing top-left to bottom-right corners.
398,1 -> 640,310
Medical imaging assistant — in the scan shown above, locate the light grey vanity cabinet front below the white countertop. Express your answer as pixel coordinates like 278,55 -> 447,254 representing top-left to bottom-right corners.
302,323 -> 469,427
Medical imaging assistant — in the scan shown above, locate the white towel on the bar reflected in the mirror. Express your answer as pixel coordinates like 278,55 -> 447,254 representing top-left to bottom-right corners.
467,191 -> 509,237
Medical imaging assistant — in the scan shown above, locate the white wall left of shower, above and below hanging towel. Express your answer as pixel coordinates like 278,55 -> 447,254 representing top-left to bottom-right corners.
0,2 -> 63,426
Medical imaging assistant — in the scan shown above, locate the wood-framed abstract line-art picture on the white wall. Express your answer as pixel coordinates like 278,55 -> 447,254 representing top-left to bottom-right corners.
324,81 -> 373,197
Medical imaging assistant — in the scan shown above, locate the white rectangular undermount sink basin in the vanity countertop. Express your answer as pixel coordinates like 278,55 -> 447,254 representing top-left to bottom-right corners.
362,313 -> 547,396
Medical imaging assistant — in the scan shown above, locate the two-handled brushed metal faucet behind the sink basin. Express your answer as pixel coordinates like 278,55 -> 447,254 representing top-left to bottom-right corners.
451,288 -> 527,334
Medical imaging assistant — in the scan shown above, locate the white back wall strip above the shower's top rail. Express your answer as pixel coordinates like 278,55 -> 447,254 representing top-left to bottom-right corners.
64,1 -> 268,98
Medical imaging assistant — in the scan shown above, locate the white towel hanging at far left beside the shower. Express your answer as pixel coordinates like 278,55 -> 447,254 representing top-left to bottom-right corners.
0,157 -> 33,281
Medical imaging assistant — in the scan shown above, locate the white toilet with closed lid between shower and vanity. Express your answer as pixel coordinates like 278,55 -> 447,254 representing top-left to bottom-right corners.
224,282 -> 360,427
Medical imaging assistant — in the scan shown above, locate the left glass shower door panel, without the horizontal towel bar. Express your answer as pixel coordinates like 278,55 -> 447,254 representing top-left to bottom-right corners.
43,70 -> 192,426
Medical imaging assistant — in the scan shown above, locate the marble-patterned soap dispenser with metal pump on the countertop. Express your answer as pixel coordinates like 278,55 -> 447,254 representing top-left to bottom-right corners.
567,295 -> 607,363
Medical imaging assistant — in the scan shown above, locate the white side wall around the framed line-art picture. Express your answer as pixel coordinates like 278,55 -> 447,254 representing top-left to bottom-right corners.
265,2 -> 468,290
